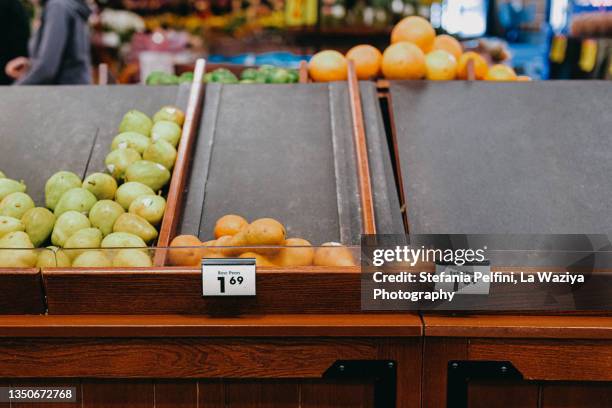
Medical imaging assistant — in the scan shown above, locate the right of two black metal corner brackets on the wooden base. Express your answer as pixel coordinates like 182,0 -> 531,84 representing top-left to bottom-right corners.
446,360 -> 523,408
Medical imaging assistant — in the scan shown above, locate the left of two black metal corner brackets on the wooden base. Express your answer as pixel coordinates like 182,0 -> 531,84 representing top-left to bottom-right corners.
323,360 -> 397,408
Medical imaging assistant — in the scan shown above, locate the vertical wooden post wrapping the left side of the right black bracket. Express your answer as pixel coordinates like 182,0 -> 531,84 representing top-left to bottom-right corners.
422,337 -> 468,408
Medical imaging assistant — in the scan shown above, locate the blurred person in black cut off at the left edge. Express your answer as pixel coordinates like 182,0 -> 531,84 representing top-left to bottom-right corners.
0,0 -> 30,85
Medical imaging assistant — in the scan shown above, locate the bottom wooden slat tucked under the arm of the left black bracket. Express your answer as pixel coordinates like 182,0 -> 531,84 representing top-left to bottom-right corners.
300,382 -> 374,408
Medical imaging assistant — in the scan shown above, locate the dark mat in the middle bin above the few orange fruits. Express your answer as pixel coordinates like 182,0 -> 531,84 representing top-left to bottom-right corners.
179,83 -> 362,245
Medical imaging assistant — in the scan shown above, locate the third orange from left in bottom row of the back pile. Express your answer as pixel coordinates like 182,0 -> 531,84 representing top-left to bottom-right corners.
382,42 -> 425,79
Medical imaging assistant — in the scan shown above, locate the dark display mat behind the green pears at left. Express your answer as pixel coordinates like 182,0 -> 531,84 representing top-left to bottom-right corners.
0,86 -> 189,205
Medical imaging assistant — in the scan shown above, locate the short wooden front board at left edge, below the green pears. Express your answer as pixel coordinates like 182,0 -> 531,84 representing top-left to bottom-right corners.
0,269 -> 45,314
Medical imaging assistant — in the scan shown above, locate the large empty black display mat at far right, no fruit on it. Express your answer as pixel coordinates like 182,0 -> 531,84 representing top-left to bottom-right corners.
390,81 -> 612,234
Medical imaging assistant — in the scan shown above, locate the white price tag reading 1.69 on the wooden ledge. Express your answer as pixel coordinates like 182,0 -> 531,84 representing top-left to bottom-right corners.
202,258 -> 256,296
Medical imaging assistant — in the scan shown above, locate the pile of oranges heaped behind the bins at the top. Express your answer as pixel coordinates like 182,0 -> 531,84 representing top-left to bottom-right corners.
308,16 -> 530,82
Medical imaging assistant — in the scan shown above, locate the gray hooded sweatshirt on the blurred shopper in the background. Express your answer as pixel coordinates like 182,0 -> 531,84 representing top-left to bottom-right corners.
17,0 -> 91,85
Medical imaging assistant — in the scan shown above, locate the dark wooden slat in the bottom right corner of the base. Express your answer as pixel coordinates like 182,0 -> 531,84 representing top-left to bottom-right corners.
541,383 -> 612,408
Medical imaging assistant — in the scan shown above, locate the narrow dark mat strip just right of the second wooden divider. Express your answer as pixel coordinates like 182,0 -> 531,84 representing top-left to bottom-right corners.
359,81 -> 404,234
